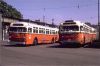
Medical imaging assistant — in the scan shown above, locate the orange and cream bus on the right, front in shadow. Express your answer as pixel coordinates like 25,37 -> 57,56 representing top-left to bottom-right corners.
59,20 -> 97,46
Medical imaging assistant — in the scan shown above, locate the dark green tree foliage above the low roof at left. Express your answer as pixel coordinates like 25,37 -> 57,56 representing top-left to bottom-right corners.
0,0 -> 23,19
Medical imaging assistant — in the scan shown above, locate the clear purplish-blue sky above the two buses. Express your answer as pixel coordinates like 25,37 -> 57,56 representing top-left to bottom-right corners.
4,0 -> 98,25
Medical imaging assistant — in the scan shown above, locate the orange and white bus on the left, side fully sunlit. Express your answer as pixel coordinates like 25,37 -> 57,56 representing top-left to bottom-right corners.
9,22 -> 59,45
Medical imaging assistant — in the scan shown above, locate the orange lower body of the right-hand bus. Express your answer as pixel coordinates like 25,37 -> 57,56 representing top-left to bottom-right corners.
59,33 -> 96,44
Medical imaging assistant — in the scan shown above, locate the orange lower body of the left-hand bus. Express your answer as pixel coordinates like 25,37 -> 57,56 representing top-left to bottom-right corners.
9,33 -> 59,44
